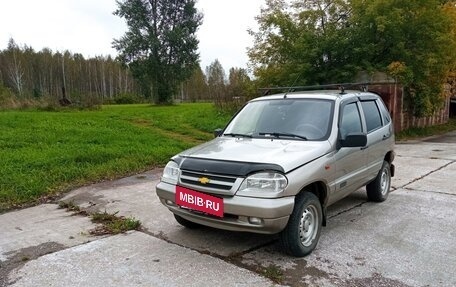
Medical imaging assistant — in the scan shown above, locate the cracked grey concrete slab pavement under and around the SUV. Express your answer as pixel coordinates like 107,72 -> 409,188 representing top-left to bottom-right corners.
0,133 -> 456,286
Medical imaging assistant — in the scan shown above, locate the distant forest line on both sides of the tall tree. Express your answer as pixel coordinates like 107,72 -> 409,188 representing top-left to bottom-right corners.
0,39 -> 256,109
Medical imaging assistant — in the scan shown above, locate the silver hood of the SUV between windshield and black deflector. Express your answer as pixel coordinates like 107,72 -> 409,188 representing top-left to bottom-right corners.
179,137 -> 331,172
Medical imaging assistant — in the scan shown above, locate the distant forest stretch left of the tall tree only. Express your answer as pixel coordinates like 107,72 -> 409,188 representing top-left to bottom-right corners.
0,39 -> 139,108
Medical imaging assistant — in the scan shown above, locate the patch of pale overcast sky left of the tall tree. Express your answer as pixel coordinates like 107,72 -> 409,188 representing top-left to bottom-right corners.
0,0 -> 126,57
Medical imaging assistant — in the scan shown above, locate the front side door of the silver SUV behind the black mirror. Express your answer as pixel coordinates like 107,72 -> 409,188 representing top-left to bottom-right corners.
331,100 -> 367,203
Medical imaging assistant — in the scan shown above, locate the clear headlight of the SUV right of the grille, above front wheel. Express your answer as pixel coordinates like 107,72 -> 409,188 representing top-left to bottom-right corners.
239,172 -> 288,193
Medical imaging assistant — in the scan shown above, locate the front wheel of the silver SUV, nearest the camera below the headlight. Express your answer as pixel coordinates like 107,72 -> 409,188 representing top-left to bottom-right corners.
280,191 -> 323,257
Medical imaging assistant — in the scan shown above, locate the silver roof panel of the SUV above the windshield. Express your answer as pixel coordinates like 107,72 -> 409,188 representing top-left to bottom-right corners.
251,90 -> 378,102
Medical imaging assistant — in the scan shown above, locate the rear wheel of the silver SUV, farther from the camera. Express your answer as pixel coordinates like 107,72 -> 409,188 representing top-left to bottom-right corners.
366,161 -> 391,202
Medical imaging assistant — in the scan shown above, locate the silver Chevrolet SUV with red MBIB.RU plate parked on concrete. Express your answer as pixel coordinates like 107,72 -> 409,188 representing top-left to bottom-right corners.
156,90 -> 395,256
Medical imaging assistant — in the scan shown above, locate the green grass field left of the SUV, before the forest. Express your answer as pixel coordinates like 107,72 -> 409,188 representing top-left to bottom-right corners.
0,103 -> 230,212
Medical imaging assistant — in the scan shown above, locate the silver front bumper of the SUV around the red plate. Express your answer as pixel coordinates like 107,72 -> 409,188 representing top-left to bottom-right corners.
156,182 -> 294,234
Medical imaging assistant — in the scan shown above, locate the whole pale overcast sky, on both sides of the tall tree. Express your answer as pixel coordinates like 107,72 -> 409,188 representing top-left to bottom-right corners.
0,0 -> 264,73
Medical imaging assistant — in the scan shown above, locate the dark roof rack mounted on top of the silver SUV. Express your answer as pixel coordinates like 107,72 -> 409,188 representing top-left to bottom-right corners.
258,82 -> 382,96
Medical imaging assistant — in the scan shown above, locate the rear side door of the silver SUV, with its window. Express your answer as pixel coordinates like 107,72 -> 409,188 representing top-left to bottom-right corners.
361,98 -> 393,181
